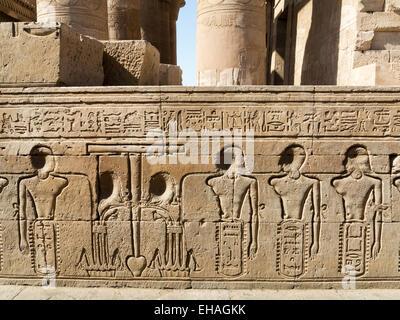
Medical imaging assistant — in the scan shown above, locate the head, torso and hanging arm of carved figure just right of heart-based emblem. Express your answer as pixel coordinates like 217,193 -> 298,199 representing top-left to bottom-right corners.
207,147 -> 258,259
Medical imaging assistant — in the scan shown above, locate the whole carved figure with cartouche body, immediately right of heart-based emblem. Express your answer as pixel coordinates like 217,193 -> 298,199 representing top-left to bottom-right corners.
207,147 -> 259,276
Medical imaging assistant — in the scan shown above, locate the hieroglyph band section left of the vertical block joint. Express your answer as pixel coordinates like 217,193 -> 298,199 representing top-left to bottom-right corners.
0,108 -> 160,137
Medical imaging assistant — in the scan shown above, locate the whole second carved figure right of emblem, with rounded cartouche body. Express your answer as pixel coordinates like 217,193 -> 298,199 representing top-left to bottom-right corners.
269,145 -> 321,277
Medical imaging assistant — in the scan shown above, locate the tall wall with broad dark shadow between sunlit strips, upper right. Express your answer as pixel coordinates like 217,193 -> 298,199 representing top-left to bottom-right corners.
294,0 -> 358,85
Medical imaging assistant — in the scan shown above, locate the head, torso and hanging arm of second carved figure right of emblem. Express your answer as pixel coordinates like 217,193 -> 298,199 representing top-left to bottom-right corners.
269,144 -> 321,254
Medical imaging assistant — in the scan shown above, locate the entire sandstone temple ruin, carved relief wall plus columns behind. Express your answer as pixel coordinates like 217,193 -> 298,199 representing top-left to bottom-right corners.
0,0 -> 400,296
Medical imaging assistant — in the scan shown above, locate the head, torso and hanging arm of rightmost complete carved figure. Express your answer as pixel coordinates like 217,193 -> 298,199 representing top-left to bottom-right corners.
332,145 -> 387,259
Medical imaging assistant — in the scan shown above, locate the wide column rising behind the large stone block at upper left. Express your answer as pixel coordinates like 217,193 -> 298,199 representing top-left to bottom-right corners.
37,0 -> 108,40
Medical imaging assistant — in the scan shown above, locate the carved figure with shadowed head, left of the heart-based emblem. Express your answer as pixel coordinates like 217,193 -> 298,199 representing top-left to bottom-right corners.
19,145 -> 68,272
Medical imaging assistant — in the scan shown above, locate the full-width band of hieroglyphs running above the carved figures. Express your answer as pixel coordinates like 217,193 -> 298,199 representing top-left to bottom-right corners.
0,106 -> 400,139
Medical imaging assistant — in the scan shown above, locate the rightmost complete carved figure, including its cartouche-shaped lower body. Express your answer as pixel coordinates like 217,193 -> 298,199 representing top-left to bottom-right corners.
332,145 -> 387,276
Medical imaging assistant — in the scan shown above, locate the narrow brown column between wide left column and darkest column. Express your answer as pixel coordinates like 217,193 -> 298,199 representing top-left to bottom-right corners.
107,0 -> 141,40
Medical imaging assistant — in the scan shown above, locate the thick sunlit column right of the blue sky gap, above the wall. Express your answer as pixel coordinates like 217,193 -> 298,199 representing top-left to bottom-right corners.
197,0 -> 266,86
